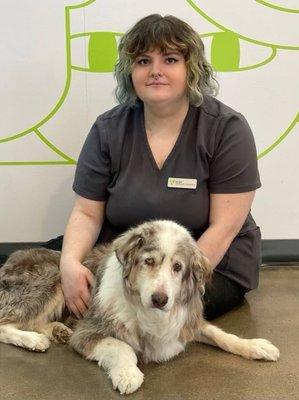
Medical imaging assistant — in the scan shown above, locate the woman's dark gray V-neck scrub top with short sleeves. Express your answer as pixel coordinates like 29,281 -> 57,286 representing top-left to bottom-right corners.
73,96 -> 261,289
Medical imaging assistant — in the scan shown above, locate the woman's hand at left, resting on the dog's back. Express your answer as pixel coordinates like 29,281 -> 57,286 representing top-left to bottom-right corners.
60,260 -> 95,318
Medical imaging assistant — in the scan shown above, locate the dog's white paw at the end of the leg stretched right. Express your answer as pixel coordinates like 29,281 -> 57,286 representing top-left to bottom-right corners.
246,339 -> 280,361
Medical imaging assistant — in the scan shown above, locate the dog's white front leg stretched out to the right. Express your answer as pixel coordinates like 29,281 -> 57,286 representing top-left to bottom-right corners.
196,321 -> 279,361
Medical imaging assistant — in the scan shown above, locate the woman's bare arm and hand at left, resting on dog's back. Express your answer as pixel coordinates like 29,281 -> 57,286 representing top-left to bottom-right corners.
60,196 -> 105,318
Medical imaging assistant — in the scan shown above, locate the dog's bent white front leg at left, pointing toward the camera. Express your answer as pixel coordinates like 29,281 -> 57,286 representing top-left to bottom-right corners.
87,337 -> 143,394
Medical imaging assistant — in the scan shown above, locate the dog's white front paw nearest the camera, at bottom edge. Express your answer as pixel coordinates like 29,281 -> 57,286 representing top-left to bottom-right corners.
109,365 -> 143,394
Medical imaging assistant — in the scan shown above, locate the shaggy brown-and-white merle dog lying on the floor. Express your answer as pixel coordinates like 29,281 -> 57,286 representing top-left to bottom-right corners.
0,220 -> 279,394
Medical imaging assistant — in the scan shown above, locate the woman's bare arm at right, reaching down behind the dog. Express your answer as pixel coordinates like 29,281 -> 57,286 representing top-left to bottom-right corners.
197,191 -> 255,268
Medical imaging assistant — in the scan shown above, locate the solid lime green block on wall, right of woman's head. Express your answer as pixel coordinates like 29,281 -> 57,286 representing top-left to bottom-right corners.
211,32 -> 240,72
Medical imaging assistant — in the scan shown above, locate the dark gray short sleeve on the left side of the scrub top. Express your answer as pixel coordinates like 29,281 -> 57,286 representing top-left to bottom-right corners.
73,118 -> 111,201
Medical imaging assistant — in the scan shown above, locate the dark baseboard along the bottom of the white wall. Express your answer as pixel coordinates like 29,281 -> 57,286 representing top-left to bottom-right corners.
0,237 -> 299,265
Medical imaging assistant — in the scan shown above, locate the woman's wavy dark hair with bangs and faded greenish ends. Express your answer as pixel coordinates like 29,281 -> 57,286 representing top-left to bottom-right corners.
115,14 -> 218,106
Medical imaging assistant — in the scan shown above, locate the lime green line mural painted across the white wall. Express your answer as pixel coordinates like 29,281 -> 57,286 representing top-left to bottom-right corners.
0,0 -> 299,165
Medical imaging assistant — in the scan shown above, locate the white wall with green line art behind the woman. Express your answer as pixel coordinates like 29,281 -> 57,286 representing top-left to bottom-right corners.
0,0 -> 299,242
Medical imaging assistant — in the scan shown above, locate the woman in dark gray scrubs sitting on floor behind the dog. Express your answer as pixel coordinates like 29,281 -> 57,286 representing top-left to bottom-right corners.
60,14 -> 260,319
